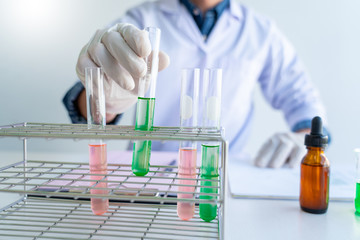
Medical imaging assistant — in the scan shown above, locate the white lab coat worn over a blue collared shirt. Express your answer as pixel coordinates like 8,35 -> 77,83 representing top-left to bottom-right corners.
63,0 -> 327,154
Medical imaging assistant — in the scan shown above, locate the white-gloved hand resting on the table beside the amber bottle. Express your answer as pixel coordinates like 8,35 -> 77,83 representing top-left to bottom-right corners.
255,132 -> 306,168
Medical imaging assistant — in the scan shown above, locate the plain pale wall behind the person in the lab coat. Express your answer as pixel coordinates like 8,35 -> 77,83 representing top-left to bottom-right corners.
0,0 -> 360,162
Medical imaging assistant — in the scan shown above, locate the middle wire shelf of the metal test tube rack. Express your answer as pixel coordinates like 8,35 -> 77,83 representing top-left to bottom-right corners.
0,160 -> 222,204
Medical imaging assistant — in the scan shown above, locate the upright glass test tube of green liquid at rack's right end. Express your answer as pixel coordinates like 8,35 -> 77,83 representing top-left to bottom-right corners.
199,68 -> 222,222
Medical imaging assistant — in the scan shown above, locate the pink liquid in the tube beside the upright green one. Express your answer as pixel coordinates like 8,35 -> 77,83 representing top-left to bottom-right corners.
177,148 -> 196,220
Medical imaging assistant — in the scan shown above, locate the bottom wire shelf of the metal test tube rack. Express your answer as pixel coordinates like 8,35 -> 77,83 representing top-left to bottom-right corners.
0,197 -> 219,240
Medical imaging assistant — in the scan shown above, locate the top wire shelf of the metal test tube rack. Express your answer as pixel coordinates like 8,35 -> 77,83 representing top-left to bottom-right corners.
0,123 -> 222,141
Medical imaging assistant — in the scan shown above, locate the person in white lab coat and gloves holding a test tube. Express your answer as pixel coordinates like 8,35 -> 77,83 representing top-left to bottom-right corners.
63,0 -> 325,168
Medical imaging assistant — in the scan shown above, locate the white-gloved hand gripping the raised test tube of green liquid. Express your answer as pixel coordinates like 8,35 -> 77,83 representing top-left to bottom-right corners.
76,23 -> 170,114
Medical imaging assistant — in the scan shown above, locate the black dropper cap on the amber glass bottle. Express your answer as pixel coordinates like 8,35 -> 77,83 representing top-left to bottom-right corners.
305,116 -> 328,148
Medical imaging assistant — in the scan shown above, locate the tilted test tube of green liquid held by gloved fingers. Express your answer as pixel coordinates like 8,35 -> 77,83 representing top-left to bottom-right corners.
132,27 -> 161,176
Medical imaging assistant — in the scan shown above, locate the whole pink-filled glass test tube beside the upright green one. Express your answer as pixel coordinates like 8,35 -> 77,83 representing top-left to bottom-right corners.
177,68 -> 200,220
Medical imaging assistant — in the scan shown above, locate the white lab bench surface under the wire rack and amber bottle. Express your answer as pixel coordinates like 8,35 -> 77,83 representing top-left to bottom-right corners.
0,123 -> 360,240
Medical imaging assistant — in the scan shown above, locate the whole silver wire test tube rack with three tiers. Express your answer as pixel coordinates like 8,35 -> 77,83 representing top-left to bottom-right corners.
0,123 -> 228,239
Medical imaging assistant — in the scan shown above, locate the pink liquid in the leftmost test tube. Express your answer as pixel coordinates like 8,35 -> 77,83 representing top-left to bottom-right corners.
89,144 -> 109,215
